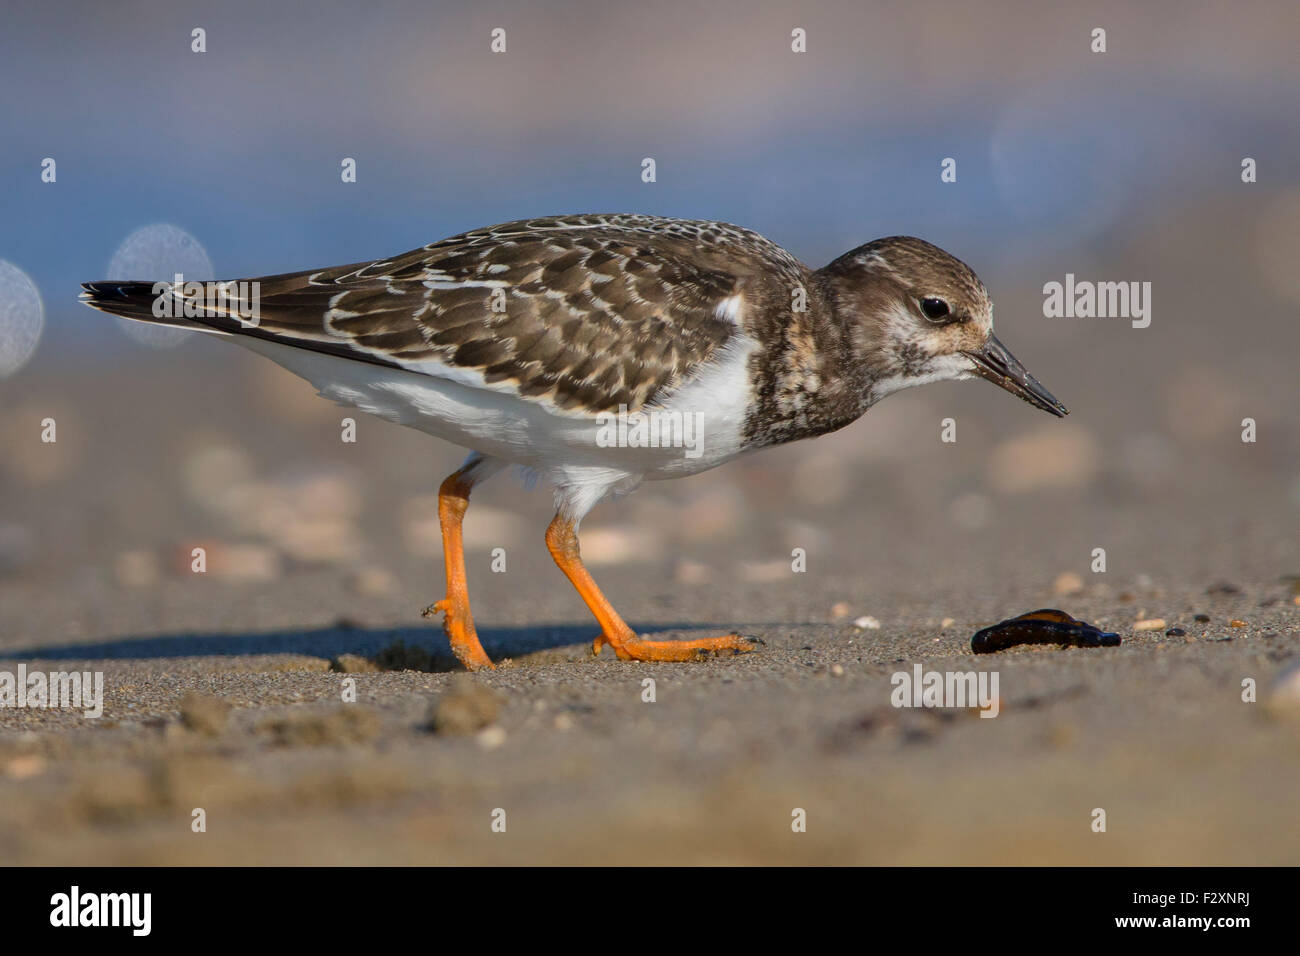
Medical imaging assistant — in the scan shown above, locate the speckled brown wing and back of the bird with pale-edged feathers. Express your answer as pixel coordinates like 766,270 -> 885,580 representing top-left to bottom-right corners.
185,216 -> 803,412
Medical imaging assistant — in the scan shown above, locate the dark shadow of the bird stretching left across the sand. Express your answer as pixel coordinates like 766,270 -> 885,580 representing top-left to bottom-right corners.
0,622 -> 722,671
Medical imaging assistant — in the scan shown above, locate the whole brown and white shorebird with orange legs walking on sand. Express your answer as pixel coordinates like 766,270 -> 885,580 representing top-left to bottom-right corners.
82,215 -> 1066,670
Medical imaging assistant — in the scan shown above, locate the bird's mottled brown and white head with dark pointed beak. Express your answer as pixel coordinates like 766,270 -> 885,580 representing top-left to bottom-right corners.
822,235 -> 1069,418
